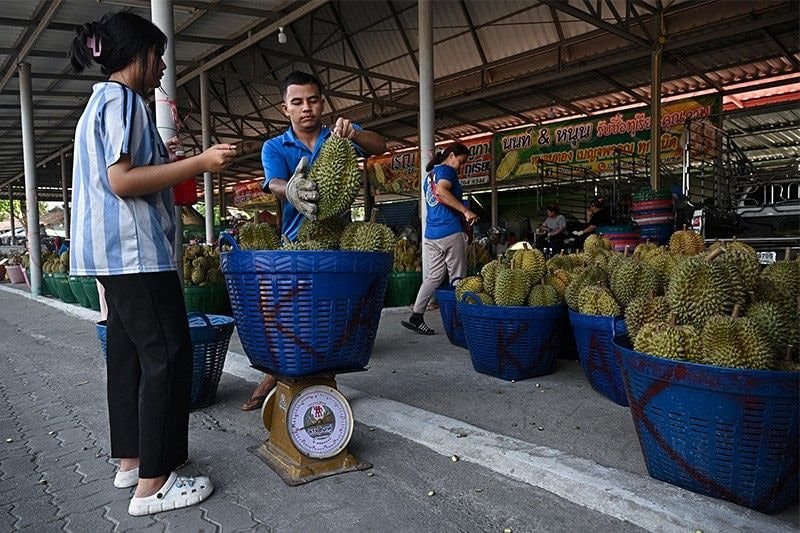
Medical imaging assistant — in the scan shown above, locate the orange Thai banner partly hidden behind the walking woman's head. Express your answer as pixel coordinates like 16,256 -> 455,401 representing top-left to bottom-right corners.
367,134 -> 492,195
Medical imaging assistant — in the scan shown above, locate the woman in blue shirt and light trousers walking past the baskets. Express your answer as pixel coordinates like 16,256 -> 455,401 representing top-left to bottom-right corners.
402,143 -> 478,335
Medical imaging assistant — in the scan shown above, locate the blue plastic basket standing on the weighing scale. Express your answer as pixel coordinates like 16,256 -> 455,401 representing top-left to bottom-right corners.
220,233 -> 392,377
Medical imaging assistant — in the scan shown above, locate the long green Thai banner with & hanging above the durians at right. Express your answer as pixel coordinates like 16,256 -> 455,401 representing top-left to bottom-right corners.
493,95 -> 722,183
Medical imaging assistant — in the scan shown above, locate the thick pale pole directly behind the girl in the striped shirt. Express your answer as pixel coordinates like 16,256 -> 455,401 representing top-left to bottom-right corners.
150,0 -> 183,283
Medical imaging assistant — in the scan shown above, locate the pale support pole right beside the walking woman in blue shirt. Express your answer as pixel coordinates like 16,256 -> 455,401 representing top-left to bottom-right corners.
417,0 -> 434,276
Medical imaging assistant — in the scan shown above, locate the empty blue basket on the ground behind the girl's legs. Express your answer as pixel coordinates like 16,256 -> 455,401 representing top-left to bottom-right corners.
95,313 -> 234,409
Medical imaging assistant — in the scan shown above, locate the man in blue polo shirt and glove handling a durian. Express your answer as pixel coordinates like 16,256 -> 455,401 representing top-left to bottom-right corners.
261,71 -> 386,241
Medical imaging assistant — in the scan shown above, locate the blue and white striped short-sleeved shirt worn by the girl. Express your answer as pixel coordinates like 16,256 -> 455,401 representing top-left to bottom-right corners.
70,81 -> 176,276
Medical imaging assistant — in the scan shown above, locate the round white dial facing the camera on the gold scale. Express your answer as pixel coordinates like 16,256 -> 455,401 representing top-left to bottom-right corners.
286,385 -> 353,459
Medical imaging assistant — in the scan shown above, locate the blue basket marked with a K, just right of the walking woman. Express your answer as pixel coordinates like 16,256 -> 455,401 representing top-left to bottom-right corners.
457,292 -> 564,381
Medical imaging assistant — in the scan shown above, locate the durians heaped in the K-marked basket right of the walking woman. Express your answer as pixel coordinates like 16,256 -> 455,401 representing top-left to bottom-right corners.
455,242 -> 564,306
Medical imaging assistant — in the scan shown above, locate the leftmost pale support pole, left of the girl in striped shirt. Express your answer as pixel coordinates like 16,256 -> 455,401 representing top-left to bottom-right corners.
19,63 -> 42,296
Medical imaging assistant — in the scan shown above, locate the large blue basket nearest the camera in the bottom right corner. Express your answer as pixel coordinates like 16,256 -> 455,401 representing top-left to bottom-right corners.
614,337 -> 800,513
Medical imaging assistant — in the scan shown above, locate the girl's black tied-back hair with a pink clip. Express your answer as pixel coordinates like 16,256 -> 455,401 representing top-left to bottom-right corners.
69,11 -> 167,90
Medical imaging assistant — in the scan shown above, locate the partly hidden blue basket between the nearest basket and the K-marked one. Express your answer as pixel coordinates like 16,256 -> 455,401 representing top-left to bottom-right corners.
569,309 -> 628,406
